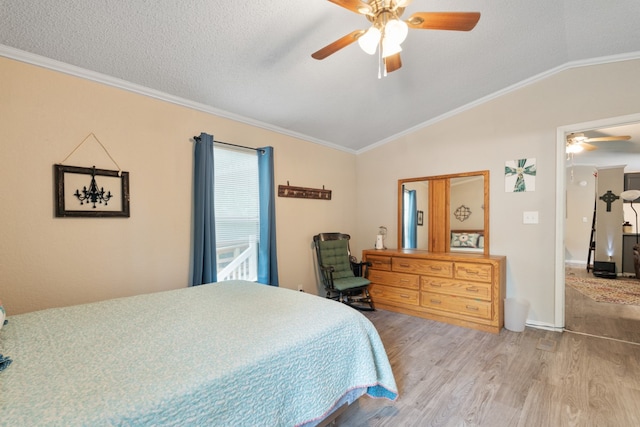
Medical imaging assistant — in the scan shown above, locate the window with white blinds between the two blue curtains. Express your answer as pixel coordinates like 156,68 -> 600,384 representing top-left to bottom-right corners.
214,145 -> 260,281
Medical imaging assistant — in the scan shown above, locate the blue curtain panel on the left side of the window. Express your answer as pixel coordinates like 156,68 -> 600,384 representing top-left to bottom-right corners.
191,133 -> 218,286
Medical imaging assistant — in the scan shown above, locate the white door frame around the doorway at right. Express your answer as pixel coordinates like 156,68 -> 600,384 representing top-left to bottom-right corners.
554,113 -> 640,330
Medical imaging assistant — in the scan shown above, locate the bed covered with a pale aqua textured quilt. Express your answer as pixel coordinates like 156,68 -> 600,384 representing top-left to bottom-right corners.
0,281 -> 397,426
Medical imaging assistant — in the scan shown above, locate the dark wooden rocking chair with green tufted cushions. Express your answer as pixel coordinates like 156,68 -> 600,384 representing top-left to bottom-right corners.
313,233 -> 375,311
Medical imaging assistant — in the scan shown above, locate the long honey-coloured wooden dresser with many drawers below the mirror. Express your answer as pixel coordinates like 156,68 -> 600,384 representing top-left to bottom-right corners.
362,249 -> 506,334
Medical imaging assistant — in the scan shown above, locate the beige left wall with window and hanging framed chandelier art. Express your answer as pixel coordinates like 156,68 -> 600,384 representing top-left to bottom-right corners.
0,57 -> 356,314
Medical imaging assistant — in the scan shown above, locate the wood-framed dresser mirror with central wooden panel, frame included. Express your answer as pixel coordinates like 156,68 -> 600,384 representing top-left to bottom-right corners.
398,171 -> 489,255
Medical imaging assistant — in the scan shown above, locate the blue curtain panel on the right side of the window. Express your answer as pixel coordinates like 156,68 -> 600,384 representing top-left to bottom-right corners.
258,147 -> 278,286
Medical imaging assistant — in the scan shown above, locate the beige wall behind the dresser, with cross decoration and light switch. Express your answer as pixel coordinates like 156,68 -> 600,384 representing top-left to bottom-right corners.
357,60 -> 640,327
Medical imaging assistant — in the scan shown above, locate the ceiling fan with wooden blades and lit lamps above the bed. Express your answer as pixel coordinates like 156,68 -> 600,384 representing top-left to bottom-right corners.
311,0 -> 480,77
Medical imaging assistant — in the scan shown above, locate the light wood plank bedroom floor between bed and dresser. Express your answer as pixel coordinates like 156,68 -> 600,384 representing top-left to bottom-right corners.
337,310 -> 640,427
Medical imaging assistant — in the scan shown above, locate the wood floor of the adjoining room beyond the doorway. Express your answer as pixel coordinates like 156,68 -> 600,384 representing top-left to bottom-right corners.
564,268 -> 640,344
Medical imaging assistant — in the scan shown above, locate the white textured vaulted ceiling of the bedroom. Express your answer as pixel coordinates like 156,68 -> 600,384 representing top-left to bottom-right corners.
0,0 -> 640,152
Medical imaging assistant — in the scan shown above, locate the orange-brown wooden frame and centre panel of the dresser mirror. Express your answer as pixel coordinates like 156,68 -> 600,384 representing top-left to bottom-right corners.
397,170 -> 490,256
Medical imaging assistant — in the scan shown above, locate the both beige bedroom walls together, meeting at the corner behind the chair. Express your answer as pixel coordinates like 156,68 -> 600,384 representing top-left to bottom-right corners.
5,58 -> 640,326
